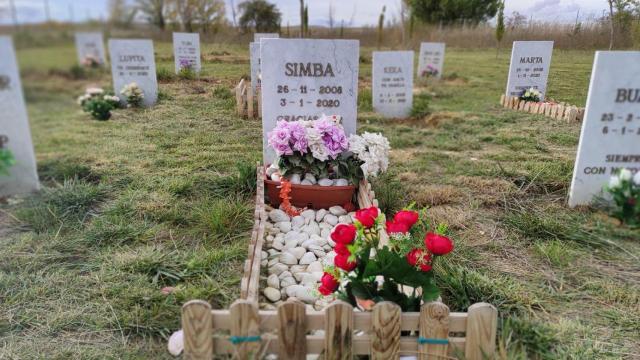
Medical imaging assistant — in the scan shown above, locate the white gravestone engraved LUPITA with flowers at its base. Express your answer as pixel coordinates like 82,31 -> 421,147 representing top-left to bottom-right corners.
109,39 -> 158,106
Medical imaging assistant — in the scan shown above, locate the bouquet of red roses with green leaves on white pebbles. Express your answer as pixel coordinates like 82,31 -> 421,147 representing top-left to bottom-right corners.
318,207 -> 453,311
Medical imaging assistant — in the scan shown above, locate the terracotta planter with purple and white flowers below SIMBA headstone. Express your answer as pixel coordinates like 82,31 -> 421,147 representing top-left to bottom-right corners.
265,115 -> 389,209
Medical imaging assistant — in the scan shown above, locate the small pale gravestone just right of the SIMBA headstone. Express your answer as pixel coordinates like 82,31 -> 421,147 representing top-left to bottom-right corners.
372,51 -> 413,118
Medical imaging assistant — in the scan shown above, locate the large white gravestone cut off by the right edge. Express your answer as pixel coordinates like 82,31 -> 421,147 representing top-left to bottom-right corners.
569,51 -> 640,207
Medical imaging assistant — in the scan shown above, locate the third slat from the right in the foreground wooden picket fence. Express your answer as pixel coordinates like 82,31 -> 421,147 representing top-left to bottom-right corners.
371,301 -> 402,360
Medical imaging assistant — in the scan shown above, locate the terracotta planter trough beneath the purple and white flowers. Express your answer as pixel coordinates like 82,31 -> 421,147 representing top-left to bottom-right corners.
264,179 -> 356,209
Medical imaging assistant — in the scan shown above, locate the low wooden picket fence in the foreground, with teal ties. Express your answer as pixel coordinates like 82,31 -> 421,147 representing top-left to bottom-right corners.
182,300 -> 498,360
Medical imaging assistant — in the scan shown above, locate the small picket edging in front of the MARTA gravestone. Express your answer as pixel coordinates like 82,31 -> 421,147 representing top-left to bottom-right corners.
500,95 -> 584,122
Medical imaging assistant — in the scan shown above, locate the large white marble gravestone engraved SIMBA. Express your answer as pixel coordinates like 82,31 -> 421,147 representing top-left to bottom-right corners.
260,39 -> 360,163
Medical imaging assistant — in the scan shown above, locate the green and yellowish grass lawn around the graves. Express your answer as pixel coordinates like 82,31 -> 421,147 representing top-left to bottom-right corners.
0,43 -> 640,359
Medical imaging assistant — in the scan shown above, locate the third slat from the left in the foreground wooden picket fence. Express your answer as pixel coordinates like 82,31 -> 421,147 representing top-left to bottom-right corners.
278,300 -> 307,360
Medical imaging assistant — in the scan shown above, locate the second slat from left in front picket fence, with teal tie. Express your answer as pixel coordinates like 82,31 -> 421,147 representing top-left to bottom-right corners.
229,300 -> 261,359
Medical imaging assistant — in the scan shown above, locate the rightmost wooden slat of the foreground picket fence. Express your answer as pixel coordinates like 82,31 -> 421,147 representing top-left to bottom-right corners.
465,303 -> 498,360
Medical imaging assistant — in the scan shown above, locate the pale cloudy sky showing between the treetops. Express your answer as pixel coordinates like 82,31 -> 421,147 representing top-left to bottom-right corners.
0,0 -> 607,26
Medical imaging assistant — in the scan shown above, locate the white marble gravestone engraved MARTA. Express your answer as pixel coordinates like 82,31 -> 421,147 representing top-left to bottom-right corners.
506,41 -> 553,100
